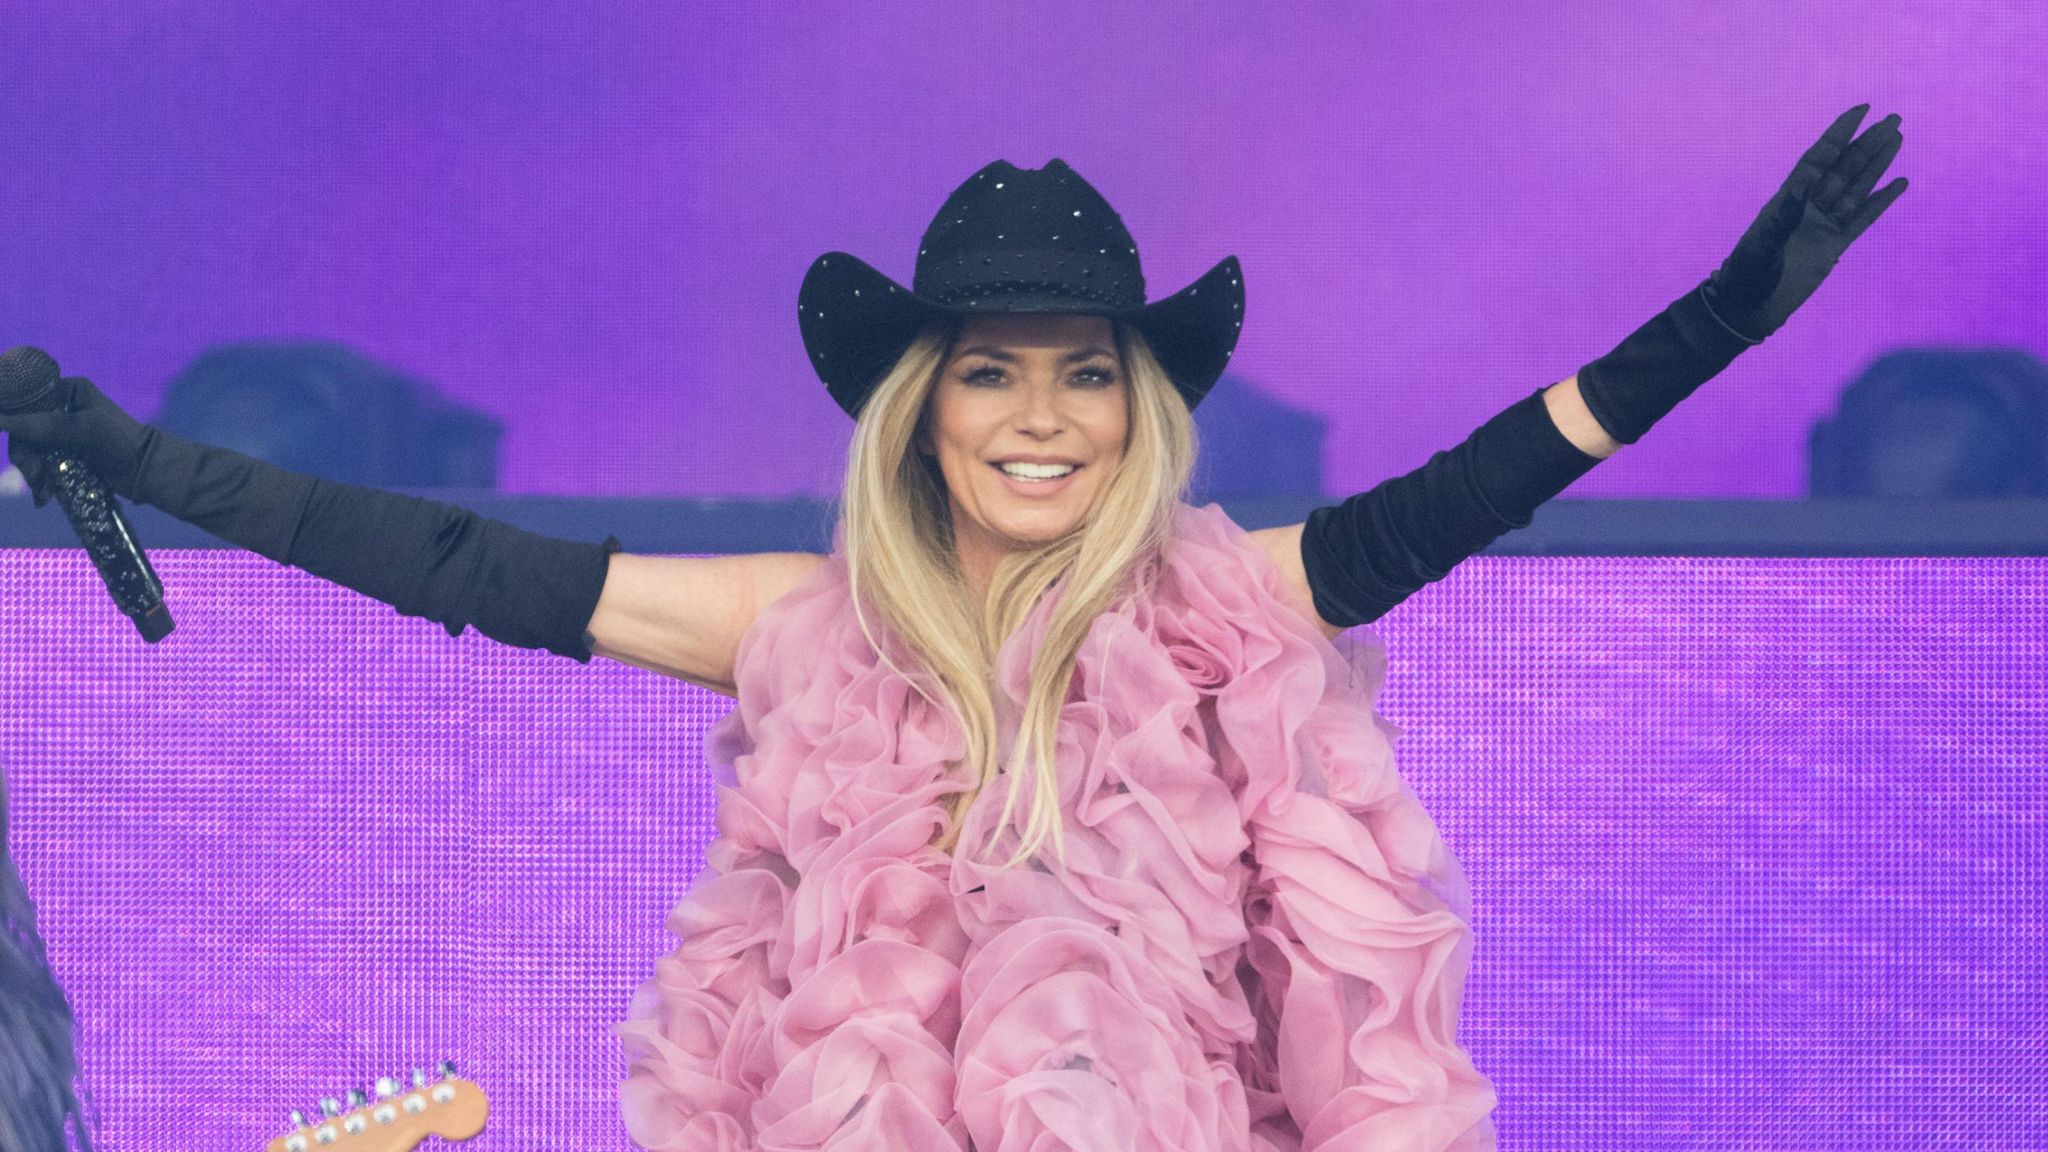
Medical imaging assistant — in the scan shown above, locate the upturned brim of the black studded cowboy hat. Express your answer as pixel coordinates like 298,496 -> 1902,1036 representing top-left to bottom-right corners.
797,252 -> 1245,418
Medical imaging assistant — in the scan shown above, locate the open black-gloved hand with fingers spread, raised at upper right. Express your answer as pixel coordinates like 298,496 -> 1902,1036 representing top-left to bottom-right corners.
1706,105 -> 1907,342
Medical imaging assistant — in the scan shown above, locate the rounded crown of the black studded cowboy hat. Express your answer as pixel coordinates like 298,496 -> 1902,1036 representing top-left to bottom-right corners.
911,160 -> 1145,314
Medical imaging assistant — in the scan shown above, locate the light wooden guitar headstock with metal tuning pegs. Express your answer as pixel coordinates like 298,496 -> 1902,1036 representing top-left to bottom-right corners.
264,1060 -> 489,1152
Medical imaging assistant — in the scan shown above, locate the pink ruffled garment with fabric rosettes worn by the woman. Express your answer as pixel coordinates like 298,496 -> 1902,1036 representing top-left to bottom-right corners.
618,504 -> 1495,1152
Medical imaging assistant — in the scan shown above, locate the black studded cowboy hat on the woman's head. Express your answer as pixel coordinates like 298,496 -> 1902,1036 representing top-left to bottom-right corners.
797,160 -> 1245,416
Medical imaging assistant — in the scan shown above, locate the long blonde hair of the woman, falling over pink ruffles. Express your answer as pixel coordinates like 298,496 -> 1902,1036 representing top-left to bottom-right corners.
840,309 -> 1196,867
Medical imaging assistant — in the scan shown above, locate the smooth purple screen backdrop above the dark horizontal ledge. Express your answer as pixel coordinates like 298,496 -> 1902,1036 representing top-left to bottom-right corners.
0,0 -> 2048,498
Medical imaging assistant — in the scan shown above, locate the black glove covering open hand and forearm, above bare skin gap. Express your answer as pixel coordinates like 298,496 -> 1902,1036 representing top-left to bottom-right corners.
1579,105 -> 1907,445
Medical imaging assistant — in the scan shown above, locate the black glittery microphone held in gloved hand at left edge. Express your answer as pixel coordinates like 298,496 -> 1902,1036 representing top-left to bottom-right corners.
0,346 -> 176,644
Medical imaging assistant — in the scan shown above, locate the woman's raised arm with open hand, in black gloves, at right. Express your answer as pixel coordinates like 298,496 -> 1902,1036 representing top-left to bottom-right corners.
1266,105 -> 1907,633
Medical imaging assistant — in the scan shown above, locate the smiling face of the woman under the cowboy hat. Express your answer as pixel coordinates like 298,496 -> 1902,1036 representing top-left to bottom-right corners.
924,312 -> 1130,576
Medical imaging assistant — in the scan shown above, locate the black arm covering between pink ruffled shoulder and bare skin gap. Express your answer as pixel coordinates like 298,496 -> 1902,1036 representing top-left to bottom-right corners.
1300,387 -> 1599,627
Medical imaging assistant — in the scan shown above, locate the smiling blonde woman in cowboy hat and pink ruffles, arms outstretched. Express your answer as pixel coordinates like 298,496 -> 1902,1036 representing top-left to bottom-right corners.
0,105 -> 1905,1152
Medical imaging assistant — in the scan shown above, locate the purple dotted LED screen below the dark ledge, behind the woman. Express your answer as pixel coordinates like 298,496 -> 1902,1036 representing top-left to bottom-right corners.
0,549 -> 2048,1150
